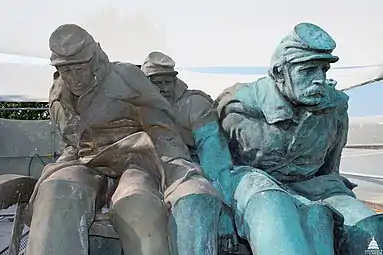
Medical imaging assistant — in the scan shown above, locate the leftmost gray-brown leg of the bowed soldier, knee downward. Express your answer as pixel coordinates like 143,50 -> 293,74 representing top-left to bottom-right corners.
26,166 -> 104,255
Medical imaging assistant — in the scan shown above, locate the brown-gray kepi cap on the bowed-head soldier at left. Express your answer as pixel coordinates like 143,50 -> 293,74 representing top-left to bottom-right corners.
49,24 -> 96,66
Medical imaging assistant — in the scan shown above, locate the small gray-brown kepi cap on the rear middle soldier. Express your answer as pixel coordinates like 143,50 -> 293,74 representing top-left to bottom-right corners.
141,51 -> 178,76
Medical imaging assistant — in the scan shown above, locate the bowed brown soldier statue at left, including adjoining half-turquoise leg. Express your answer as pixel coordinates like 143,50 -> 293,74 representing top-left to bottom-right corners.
27,24 -> 221,255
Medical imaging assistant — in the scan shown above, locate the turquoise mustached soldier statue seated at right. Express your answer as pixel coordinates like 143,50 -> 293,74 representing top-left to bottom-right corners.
217,23 -> 383,255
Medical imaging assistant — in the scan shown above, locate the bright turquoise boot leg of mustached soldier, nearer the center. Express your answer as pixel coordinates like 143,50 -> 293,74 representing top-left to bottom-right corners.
244,190 -> 314,255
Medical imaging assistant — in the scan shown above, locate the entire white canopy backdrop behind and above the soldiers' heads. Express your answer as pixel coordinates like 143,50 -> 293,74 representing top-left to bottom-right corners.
0,0 -> 383,101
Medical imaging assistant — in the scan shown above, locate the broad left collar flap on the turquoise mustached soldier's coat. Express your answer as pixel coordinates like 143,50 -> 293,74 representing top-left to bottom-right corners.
253,77 -> 295,124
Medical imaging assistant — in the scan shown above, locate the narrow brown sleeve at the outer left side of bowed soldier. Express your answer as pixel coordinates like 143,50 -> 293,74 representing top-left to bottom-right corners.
49,75 -> 77,162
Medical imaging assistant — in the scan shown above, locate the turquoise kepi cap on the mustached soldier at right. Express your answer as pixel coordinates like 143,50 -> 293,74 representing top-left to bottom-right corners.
271,23 -> 339,69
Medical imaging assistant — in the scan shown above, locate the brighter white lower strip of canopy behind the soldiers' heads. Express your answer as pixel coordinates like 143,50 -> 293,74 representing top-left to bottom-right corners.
0,59 -> 383,102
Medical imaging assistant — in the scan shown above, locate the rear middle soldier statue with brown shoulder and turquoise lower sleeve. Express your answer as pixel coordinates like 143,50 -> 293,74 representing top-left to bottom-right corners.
141,51 -> 237,254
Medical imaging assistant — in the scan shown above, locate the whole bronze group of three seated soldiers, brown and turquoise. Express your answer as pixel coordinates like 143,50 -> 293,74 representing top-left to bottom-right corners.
26,23 -> 383,255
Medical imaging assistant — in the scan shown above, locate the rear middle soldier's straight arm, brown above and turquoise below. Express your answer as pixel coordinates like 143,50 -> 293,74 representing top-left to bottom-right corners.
188,94 -> 233,205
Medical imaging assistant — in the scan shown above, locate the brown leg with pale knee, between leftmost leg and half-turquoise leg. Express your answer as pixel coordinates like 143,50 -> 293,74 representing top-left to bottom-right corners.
110,168 -> 170,255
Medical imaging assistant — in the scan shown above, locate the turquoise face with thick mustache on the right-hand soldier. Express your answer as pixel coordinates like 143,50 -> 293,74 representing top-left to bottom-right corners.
280,60 -> 330,106
